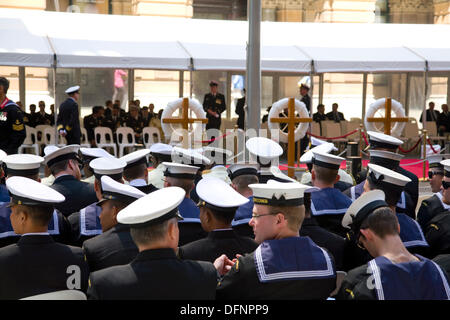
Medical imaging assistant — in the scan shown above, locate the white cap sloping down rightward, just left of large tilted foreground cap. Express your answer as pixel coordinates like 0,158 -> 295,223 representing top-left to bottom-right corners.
97,176 -> 145,206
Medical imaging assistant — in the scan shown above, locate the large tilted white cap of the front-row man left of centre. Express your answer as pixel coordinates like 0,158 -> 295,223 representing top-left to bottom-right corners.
117,187 -> 186,228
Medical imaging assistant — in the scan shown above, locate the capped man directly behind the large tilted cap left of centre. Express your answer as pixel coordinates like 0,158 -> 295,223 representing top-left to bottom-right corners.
120,149 -> 157,194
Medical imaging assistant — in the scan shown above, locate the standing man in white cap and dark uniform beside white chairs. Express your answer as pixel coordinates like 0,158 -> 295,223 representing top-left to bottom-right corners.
56,86 -> 81,145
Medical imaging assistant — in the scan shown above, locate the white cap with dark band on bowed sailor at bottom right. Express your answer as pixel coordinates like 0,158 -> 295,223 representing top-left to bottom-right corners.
341,190 -> 388,234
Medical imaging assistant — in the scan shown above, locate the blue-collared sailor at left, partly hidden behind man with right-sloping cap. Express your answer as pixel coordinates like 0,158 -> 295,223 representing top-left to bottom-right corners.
69,157 -> 127,247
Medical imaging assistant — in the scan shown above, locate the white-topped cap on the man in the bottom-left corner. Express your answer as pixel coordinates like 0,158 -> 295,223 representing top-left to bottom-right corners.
6,177 -> 66,206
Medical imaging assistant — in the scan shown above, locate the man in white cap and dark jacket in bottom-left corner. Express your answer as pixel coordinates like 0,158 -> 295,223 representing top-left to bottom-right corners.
0,177 -> 89,300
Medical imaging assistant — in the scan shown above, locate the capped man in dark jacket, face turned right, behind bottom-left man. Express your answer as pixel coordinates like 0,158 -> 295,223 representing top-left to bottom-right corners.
44,145 -> 97,217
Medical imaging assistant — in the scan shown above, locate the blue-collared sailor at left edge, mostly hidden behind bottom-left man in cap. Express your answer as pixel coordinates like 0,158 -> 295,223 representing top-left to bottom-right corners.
0,154 -> 71,247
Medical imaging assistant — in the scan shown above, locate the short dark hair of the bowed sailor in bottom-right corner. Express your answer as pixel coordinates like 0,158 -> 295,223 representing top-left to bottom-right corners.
360,207 -> 399,238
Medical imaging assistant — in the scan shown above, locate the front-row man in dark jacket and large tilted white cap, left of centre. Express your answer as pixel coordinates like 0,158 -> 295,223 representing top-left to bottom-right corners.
88,187 -> 217,300
